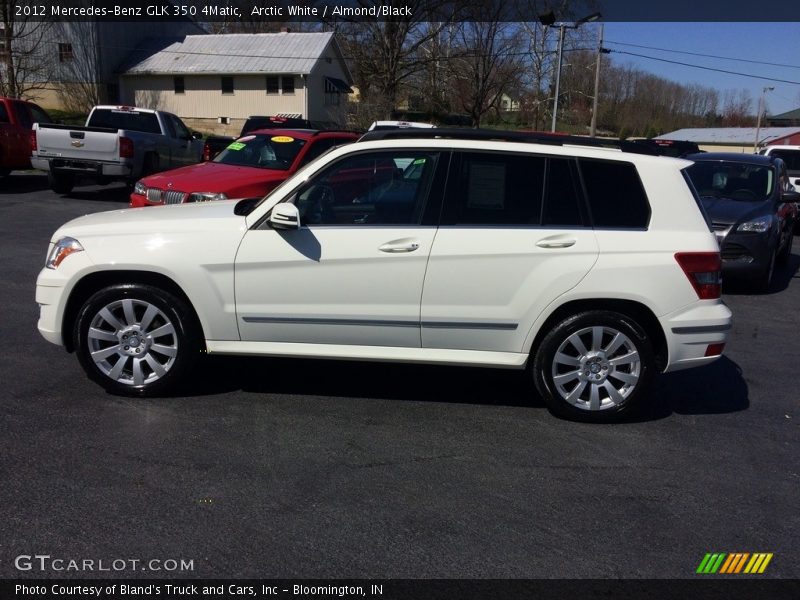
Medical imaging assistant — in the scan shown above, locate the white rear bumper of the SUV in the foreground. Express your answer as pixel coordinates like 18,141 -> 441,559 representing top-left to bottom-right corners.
659,300 -> 733,373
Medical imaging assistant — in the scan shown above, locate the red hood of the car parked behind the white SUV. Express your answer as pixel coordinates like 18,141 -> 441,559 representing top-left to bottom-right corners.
142,162 -> 292,198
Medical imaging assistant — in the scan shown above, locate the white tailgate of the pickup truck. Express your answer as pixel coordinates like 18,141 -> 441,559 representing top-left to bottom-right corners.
36,124 -> 119,162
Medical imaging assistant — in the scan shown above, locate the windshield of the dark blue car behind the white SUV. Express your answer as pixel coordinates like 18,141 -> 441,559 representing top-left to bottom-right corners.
686,161 -> 775,202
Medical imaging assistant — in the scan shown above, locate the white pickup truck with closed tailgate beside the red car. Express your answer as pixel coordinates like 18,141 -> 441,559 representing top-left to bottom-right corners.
31,106 -> 203,194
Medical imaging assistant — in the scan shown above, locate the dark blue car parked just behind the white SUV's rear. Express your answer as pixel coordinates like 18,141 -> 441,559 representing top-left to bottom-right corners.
686,152 -> 800,291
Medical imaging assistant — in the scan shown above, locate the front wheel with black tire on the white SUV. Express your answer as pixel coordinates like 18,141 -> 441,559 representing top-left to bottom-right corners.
72,284 -> 201,396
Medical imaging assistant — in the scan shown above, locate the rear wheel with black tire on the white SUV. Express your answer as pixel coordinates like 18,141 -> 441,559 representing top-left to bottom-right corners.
531,310 -> 655,423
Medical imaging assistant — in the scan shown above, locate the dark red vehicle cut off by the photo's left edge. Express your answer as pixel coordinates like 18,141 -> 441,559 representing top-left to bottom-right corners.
0,98 -> 53,176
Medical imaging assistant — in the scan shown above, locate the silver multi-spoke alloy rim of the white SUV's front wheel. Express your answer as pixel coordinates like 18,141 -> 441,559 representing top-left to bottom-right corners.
86,298 -> 178,386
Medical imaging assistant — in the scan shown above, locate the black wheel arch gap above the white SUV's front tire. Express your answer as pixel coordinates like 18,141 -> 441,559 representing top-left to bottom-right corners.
61,270 -> 205,352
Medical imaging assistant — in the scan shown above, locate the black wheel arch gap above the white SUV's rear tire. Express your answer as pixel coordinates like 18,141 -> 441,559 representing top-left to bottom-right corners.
528,298 -> 669,371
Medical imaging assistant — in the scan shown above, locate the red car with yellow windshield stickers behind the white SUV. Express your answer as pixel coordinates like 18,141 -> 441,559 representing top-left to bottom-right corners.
130,129 -> 358,207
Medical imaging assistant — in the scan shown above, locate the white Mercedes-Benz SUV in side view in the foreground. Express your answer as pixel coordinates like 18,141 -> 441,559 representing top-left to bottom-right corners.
36,129 -> 731,421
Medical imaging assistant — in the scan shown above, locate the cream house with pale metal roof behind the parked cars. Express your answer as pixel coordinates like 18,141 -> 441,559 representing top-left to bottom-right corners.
120,32 -> 352,133
